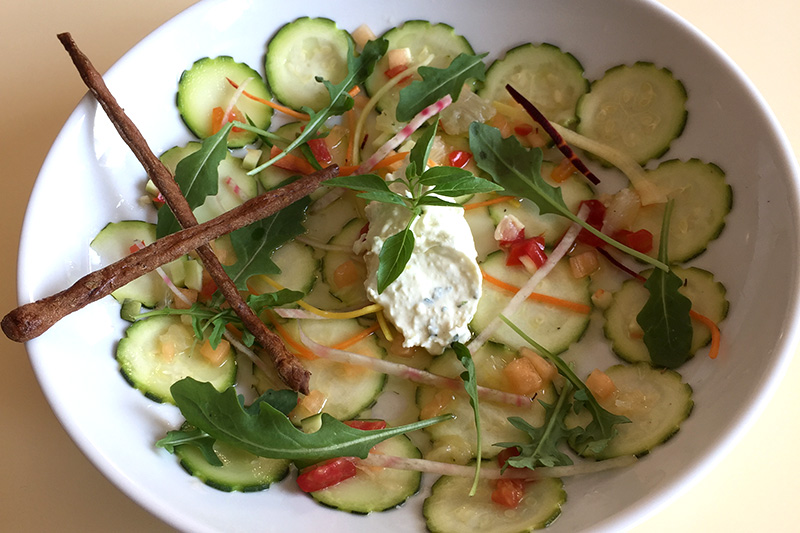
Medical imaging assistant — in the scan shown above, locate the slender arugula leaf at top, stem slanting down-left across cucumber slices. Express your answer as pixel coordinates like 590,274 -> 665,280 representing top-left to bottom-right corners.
248,38 -> 389,175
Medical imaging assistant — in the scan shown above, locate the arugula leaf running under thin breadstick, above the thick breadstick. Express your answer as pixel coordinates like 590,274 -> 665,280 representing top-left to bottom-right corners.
156,123 -> 233,239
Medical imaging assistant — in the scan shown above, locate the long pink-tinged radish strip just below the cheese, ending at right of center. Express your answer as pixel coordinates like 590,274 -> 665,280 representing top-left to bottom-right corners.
299,327 -> 531,407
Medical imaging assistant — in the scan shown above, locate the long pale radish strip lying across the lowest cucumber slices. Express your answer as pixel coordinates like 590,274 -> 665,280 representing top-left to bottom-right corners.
358,453 -> 636,479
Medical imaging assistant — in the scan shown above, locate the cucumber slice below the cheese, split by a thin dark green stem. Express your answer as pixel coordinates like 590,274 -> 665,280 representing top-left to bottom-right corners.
417,342 -> 552,464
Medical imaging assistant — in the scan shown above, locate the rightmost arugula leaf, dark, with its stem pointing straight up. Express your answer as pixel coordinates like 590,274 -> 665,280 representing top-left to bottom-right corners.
636,200 -> 693,368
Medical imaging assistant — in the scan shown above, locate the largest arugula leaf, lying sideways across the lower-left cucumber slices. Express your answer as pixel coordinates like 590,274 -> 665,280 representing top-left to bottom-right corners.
170,378 -> 451,462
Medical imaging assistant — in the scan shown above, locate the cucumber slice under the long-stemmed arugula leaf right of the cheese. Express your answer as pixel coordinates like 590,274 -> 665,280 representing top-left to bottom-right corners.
489,161 -> 594,246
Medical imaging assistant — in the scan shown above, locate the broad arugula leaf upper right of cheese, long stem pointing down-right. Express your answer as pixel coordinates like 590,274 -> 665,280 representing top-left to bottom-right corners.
469,122 -> 669,271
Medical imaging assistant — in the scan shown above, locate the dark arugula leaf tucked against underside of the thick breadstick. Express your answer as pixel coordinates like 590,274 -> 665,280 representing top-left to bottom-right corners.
224,198 -> 309,290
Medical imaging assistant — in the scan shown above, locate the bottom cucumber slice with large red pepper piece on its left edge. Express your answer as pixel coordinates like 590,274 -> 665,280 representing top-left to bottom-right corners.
311,435 -> 422,514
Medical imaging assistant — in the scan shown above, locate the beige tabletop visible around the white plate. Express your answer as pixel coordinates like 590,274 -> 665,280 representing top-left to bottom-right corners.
0,0 -> 800,532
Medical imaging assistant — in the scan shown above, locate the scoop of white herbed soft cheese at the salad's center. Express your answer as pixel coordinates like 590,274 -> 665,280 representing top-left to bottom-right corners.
353,187 -> 482,354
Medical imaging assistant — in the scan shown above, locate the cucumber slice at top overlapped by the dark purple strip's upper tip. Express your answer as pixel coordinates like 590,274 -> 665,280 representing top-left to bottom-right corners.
478,43 -> 589,126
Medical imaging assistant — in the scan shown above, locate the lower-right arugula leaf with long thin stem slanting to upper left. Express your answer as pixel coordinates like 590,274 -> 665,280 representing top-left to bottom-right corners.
500,314 -> 630,454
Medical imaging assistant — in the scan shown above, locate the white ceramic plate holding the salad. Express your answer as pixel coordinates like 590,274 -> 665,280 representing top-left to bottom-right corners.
19,0 -> 798,532
